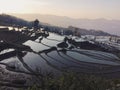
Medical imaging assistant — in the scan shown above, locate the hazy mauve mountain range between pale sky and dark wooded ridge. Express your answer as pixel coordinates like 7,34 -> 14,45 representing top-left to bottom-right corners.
9,14 -> 120,36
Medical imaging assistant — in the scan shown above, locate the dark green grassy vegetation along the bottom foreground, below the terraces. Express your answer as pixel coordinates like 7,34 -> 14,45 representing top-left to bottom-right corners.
20,73 -> 120,90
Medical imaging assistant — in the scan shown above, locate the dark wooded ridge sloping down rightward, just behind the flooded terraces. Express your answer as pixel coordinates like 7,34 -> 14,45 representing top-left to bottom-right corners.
0,14 -> 114,36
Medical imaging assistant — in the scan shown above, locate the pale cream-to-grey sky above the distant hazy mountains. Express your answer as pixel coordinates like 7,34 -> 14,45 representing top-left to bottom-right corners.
0,0 -> 120,20
